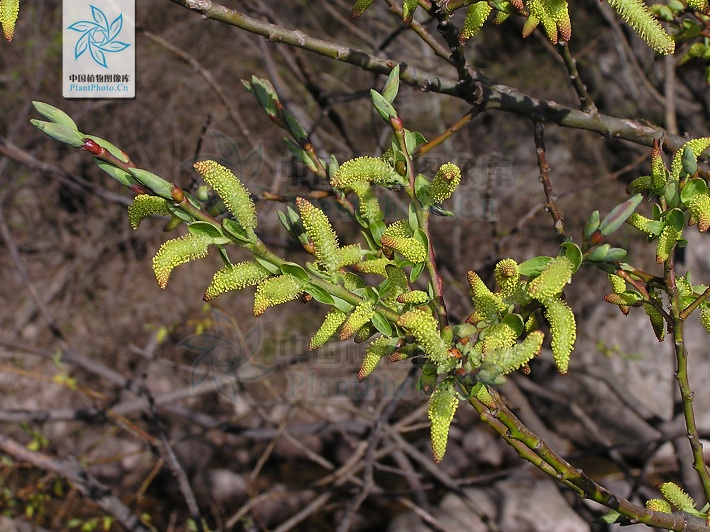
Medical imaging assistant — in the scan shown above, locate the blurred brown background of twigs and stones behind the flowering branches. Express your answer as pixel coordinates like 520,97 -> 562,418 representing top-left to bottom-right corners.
0,0 -> 710,531
